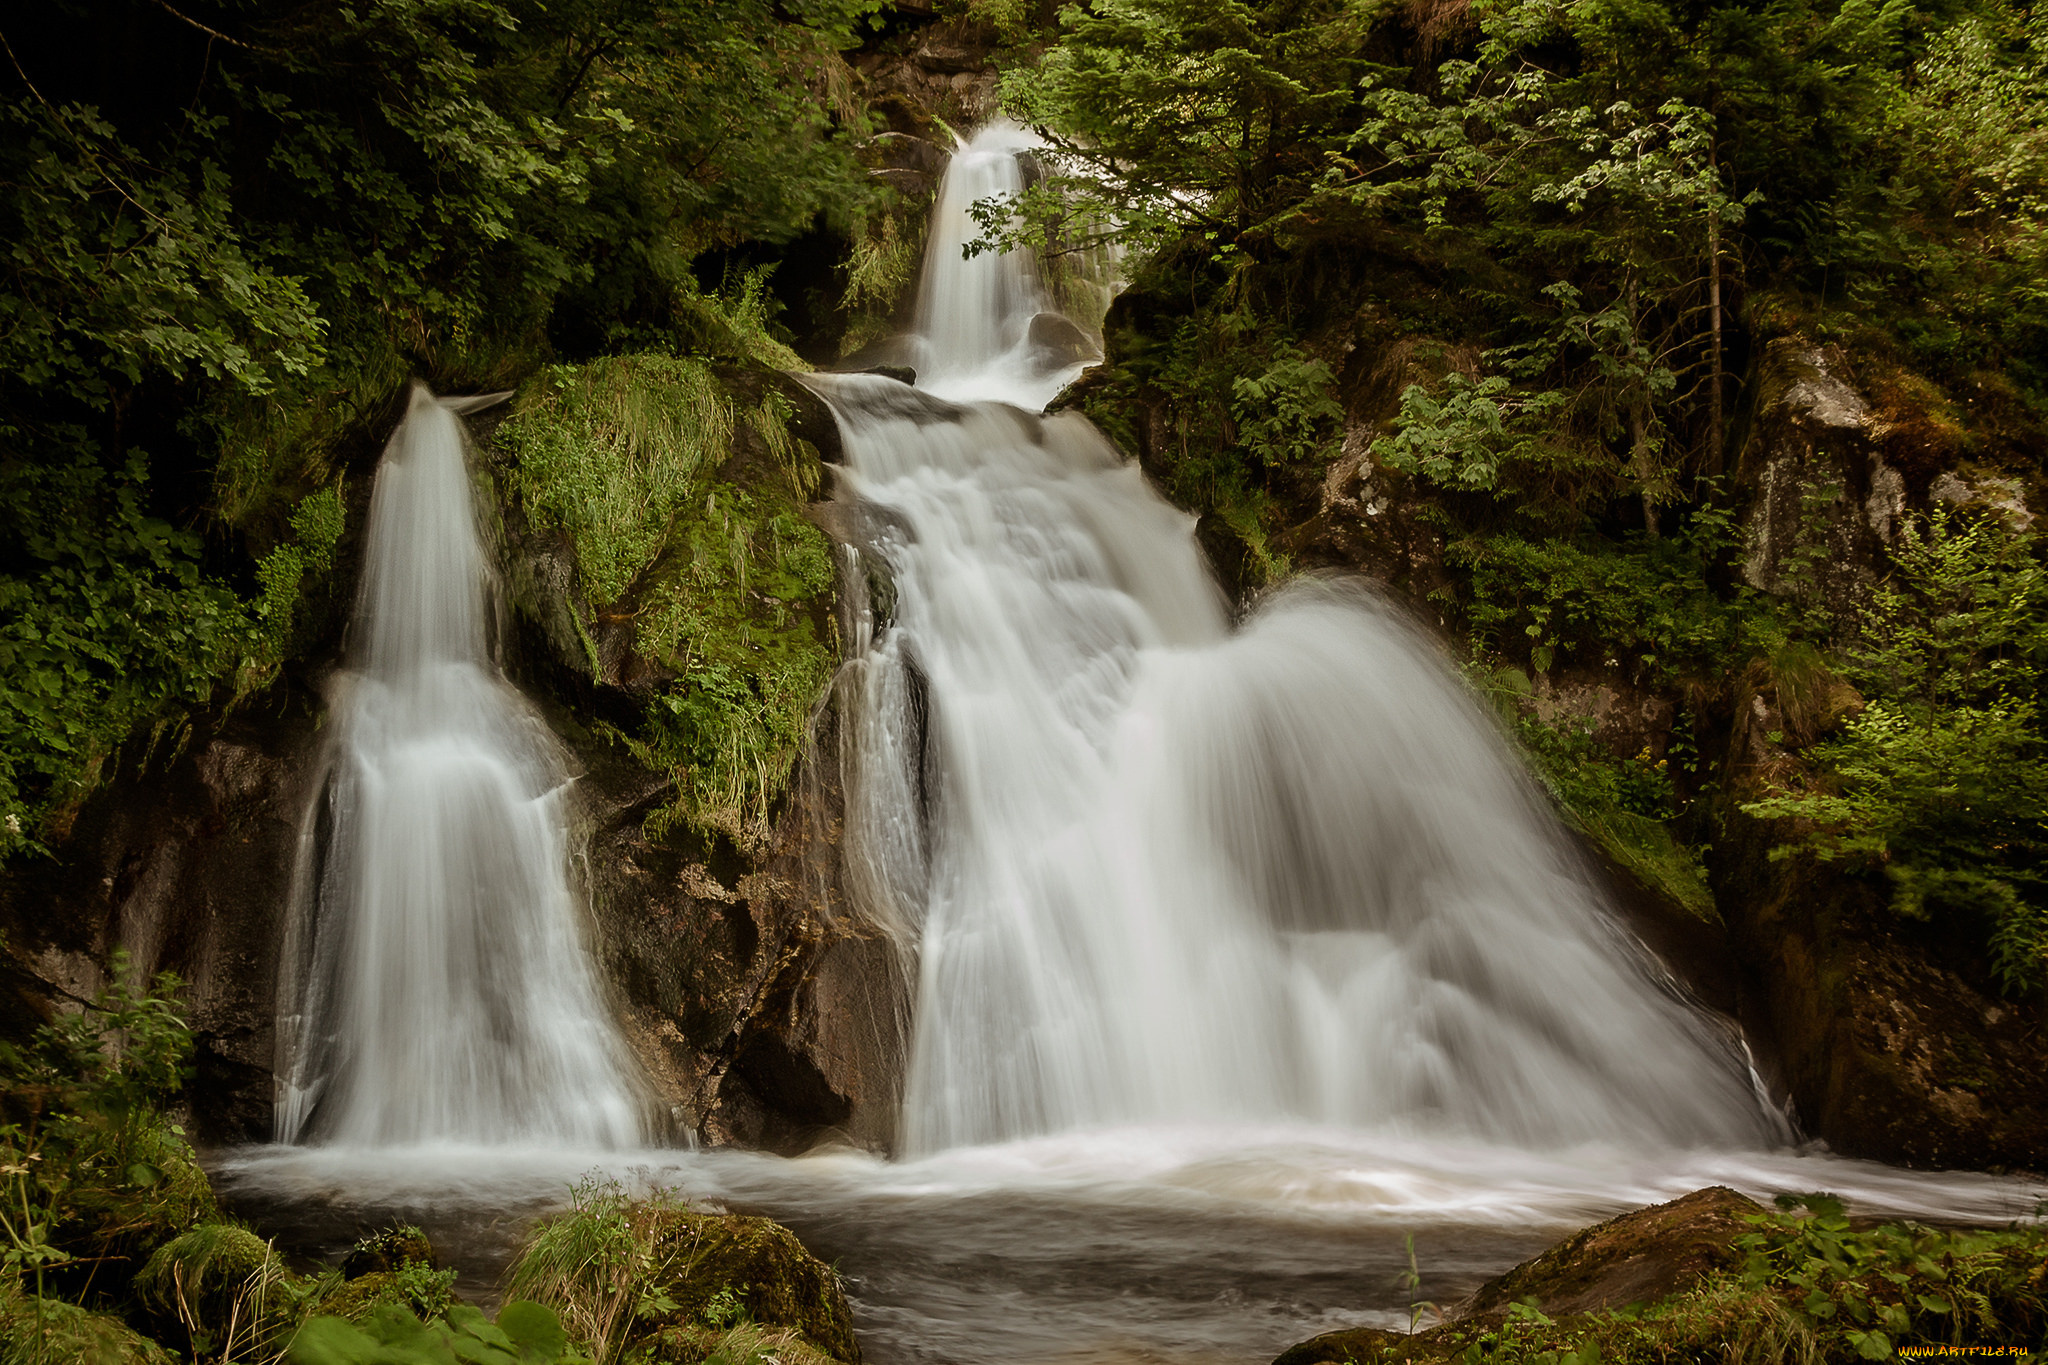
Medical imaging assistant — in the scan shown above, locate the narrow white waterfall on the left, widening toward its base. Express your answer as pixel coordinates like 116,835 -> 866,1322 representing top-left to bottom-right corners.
276,387 -> 643,1146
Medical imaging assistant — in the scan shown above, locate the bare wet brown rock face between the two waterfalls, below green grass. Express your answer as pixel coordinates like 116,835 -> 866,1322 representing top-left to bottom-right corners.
557,695 -> 909,1152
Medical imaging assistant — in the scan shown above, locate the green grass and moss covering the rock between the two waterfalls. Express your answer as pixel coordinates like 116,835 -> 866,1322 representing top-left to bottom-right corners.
500,354 -> 836,849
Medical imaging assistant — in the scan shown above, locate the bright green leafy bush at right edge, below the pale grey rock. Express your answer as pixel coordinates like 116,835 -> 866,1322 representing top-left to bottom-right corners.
1743,510 -> 2048,990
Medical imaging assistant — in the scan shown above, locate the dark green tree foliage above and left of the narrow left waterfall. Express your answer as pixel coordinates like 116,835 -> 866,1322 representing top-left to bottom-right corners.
0,0 -> 877,853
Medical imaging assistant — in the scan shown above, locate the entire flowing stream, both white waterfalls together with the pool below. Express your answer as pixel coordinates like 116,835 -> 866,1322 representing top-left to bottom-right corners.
219,127 -> 2040,1365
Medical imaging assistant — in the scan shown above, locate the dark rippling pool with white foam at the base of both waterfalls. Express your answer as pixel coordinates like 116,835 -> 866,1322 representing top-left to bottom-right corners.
211,1126 -> 2044,1365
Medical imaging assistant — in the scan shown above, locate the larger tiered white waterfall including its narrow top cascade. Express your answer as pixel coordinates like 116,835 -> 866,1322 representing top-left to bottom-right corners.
817,129 -> 1784,1154
